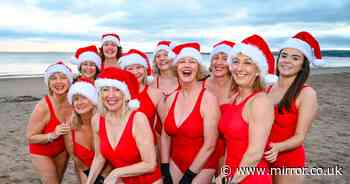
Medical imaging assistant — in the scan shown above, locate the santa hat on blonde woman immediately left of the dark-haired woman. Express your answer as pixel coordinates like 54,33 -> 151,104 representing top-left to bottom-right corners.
230,35 -> 278,84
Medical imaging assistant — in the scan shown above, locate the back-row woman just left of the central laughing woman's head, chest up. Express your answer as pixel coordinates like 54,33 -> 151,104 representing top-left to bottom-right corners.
151,41 -> 179,97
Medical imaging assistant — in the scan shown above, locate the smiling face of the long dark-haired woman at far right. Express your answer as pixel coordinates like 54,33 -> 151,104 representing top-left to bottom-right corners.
277,48 -> 305,77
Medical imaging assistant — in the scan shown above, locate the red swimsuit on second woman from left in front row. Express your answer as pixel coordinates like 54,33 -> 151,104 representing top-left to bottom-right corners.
72,130 -> 95,168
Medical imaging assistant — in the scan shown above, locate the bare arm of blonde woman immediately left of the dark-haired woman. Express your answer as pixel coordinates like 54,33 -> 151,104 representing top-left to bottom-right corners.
233,93 -> 274,182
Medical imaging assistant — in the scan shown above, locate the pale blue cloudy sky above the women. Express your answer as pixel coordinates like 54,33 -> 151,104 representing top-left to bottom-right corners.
0,0 -> 350,51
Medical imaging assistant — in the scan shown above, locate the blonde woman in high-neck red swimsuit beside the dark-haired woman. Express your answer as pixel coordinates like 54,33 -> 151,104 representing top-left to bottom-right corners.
217,35 -> 275,184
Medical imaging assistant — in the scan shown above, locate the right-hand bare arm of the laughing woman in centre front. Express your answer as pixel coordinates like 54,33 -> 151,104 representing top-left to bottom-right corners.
189,91 -> 220,173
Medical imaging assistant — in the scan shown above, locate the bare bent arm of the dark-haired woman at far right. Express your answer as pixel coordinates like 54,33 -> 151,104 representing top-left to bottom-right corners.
266,87 -> 318,162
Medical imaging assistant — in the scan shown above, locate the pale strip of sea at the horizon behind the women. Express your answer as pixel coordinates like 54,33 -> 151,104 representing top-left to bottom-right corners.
0,50 -> 350,78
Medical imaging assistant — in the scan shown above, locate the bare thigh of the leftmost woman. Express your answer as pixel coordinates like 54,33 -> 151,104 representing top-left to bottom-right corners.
30,154 -> 60,184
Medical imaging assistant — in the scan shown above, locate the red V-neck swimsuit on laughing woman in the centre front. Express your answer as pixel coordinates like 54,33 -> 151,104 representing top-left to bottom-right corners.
164,88 -> 219,173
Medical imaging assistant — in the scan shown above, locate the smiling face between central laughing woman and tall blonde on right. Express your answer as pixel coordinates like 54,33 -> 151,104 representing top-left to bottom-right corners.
210,52 -> 230,77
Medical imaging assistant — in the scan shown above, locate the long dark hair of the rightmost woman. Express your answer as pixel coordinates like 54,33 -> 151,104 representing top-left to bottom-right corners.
276,49 -> 310,114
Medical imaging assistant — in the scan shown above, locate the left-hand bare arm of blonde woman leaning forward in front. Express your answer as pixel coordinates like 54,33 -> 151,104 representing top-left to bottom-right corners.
86,113 -> 106,184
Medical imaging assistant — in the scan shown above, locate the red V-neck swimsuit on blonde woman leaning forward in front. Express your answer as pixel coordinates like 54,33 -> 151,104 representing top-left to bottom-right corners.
99,111 -> 161,184
